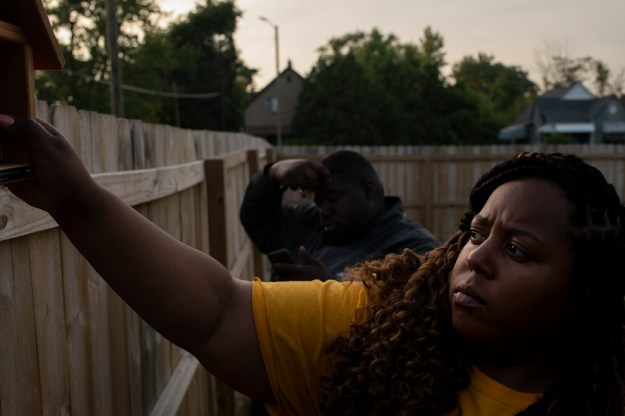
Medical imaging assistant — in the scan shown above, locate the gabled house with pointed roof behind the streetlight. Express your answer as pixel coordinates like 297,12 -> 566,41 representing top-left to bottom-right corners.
244,61 -> 304,144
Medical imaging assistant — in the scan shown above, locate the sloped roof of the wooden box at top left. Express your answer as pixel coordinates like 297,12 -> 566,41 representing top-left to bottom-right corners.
0,0 -> 65,69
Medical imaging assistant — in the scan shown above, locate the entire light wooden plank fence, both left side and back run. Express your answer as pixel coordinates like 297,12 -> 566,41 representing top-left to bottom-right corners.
6,103 -> 625,416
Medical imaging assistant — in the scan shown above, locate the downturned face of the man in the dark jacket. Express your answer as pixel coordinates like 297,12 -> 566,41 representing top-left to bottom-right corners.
315,178 -> 373,245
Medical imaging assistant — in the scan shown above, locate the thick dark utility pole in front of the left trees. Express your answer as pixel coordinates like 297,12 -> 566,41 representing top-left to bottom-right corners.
106,0 -> 124,117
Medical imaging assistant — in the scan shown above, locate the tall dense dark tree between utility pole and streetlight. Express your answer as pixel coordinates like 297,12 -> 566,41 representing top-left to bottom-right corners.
148,1 -> 256,131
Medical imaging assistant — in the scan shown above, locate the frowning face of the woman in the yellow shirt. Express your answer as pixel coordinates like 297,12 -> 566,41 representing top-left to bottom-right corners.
449,179 -> 575,354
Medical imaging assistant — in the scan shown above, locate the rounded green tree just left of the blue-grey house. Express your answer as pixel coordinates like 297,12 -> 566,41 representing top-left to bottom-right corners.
452,53 -> 538,125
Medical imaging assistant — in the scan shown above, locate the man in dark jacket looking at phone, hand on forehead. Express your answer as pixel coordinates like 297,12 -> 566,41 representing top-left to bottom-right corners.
240,150 -> 439,280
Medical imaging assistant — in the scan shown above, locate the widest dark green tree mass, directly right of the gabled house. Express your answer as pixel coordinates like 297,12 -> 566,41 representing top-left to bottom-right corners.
293,28 -> 503,145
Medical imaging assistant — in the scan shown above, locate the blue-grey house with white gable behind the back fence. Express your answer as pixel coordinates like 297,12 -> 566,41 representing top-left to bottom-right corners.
499,82 -> 625,143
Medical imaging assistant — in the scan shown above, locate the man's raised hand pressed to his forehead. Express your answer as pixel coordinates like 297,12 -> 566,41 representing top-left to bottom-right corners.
267,159 -> 332,195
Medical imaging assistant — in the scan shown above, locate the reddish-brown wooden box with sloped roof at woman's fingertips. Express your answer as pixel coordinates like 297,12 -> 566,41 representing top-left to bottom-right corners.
0,0 -> 64,183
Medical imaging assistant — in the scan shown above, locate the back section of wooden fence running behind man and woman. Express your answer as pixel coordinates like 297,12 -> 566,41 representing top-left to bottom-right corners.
278,144 -> 625,240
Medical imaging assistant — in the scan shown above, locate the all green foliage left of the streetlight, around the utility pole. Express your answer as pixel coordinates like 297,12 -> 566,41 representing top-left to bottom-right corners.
36,0 -> 255,130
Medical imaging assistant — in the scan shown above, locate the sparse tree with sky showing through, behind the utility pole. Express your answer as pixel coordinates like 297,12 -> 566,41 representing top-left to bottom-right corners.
36,0 -> 161,112
